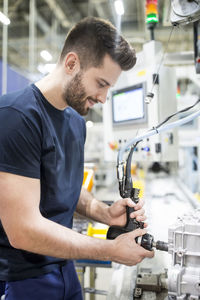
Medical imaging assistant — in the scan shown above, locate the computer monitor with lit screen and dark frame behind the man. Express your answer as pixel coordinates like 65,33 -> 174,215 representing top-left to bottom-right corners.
112,83 -> 147,125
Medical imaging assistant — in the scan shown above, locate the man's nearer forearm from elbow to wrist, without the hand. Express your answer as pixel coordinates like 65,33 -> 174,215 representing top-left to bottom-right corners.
11,216 -> 113,260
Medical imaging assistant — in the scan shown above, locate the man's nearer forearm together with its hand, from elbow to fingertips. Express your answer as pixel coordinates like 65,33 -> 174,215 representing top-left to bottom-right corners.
8,216 -> 153,266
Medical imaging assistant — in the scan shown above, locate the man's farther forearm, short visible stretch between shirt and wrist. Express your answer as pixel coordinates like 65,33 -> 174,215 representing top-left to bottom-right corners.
76,188 -> 110,225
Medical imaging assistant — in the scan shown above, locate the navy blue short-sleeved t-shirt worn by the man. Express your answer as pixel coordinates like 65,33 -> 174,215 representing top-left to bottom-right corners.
0,84 -> 86,281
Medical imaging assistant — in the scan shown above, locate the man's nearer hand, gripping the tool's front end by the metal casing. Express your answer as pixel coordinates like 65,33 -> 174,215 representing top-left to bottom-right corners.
112,229 -> 154,266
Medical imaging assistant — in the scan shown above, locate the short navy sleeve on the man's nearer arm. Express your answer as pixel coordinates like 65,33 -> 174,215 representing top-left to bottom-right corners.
0,107 -> 41,178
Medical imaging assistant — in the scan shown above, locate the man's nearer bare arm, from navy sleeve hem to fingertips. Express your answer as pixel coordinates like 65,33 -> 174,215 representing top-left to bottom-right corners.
0,172 -> 153,265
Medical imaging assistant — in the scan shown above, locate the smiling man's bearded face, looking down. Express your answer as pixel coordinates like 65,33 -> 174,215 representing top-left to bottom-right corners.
63,55 -> 121,115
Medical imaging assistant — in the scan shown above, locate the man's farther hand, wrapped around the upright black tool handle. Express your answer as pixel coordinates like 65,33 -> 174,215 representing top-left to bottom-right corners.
108,198 -> 147,227
